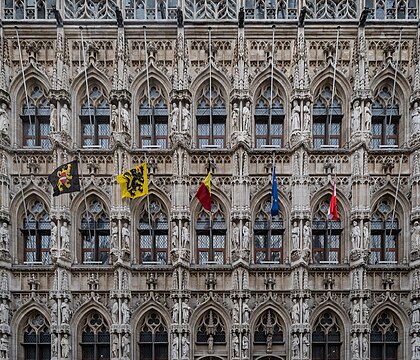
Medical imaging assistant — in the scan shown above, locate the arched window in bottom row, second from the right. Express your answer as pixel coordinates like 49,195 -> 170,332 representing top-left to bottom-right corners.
312,312 -> 341,360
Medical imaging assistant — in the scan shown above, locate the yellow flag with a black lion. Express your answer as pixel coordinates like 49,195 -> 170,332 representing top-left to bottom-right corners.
117,163 -> 149,199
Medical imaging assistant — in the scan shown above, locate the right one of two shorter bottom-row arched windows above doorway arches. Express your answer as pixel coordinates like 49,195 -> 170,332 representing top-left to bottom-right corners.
254,310 -> 284,352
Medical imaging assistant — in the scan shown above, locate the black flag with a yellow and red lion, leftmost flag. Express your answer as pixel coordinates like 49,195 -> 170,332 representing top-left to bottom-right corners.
48,160 -> 80,196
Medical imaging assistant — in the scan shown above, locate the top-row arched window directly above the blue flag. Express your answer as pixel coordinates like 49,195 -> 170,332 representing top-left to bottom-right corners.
255,85 -> 284,148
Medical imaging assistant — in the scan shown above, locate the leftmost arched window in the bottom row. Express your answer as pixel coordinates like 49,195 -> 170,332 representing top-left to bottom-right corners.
22,312 -> 51,360
